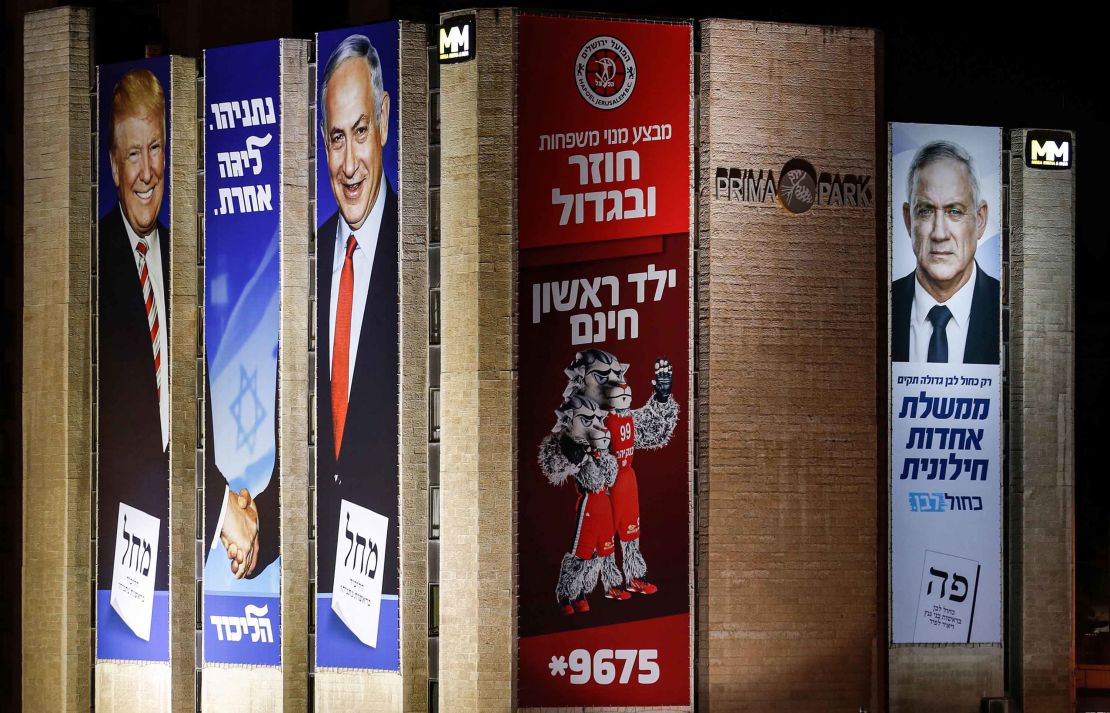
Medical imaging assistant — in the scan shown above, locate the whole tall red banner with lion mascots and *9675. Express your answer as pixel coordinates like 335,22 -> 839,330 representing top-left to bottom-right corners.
517,14 -> 692,707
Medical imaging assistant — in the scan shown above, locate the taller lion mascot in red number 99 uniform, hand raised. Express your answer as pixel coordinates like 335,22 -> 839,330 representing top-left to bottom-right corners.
563,349 -> 678,594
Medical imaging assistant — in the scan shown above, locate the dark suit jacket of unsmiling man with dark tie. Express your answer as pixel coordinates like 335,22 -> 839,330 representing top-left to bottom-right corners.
890,264 -> 1000,364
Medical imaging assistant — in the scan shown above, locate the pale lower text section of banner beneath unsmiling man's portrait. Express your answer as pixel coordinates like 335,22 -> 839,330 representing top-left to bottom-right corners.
890,363 -> 1002,643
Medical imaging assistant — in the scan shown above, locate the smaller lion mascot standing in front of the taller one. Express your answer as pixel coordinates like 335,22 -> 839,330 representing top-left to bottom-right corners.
538,395 -> 630,615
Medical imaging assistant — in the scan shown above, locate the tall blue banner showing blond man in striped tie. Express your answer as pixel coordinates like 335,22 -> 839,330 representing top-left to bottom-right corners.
95,58 -> 171,661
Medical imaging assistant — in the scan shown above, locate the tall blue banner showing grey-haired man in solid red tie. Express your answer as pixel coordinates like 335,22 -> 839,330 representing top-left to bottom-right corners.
315,22 -> 401,671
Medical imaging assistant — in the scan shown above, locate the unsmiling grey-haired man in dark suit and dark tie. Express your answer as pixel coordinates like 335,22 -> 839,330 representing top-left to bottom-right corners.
890,141 -> 999,364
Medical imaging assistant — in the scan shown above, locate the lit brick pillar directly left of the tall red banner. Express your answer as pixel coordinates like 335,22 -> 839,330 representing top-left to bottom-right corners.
440,10 -> 516,712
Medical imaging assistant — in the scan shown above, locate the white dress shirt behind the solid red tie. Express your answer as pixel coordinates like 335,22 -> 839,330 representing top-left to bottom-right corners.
327,182 -> 386,398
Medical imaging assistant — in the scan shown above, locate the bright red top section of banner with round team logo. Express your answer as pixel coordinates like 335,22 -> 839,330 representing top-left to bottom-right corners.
517,16 -> 690,249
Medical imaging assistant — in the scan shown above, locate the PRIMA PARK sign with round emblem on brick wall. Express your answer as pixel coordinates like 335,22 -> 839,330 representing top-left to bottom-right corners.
714,159 -> 875,214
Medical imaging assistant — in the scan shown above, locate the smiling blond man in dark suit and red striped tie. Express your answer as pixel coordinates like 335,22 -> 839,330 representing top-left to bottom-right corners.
97,69 -> 170,604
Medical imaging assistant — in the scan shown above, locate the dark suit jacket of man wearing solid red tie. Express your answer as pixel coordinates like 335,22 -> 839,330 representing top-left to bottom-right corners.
316,183 -> 401,594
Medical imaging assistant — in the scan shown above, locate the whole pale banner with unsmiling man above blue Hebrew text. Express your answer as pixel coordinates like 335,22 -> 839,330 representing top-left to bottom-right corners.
889,123 -> 1002,644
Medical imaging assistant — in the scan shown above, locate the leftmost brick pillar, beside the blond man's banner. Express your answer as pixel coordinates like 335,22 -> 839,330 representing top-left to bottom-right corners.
22,8 -> 93,713
